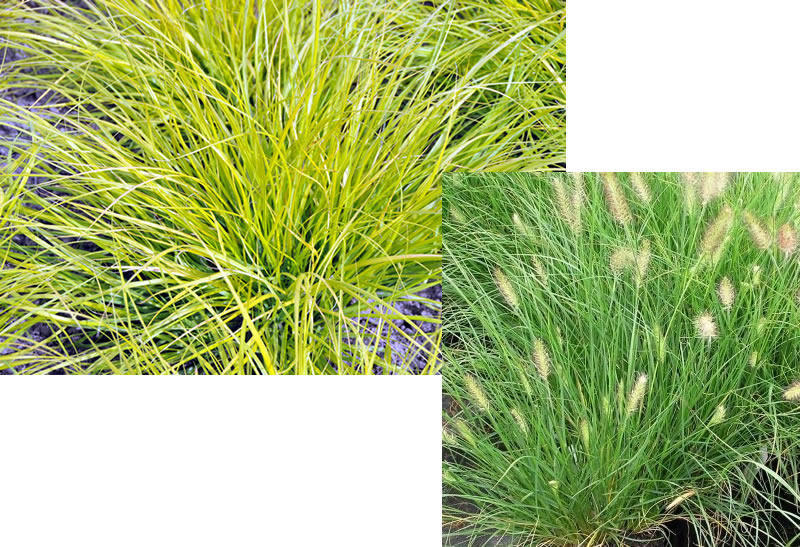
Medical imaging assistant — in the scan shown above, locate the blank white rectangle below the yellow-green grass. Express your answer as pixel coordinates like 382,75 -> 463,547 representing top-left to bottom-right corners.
0,382 -> 441,547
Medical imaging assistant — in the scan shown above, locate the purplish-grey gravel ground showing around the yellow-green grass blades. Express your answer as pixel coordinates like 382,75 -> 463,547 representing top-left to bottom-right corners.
0,5 -> 442,374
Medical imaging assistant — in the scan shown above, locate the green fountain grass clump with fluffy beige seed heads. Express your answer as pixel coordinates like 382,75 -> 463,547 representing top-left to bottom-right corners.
443,173 -> 800,546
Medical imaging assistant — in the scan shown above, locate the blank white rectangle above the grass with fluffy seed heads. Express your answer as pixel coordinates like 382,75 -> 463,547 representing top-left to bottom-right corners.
567,0 -> 800,171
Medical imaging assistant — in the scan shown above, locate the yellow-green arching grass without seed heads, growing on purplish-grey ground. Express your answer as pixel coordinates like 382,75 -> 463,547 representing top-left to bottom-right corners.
0,0 -> 565,374
